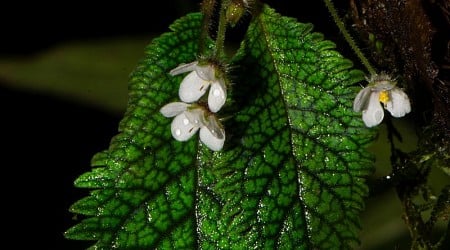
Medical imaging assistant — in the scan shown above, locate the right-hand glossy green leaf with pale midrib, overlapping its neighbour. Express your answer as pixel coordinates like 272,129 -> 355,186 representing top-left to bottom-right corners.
212,6 -> 373,249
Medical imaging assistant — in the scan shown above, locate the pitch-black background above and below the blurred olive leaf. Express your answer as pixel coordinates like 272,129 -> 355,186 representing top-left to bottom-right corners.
0,0 -> 358,249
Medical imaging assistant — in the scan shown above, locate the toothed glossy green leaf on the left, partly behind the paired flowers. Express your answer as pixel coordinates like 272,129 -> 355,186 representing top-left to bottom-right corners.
65,13 -> 219,249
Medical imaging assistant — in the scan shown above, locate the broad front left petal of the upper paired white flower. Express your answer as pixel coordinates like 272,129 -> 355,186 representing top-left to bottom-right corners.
178,71 -> 210,103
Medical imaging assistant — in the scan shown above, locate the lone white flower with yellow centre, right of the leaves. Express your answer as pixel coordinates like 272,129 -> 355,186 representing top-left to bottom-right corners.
353,74 -> 411,127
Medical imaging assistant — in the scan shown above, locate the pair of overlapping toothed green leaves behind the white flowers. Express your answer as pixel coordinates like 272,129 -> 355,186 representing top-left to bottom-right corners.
66,6 -> 373,249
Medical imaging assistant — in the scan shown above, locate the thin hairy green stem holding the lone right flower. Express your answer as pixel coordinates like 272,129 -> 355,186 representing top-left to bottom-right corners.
323,0 -> 376,75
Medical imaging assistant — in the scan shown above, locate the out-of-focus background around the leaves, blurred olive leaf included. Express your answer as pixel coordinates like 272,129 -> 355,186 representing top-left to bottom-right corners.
0,0 -> 446,249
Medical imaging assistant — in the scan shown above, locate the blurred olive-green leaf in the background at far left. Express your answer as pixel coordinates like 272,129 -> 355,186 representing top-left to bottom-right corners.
0,36 -> 149,114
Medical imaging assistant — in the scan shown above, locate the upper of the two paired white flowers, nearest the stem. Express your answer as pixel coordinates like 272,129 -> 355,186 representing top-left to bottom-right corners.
170,61 -> 227,113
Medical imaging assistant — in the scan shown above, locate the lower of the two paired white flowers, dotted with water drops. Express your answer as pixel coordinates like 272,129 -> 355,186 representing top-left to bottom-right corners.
160,102 -> 225,151
